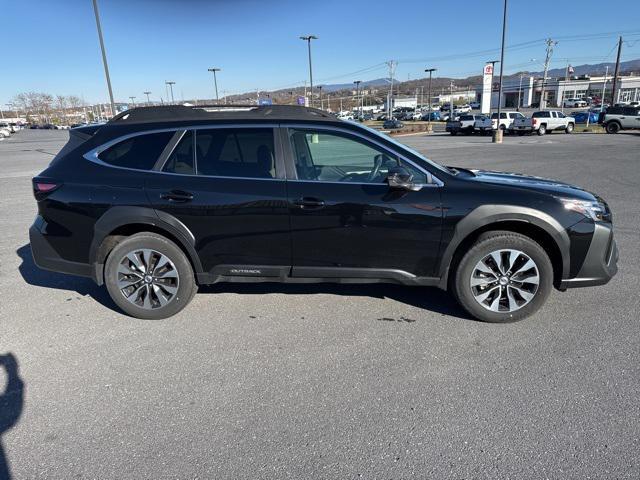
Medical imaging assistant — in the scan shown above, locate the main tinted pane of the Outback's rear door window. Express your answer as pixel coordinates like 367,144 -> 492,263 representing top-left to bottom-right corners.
196,128 -> 276,178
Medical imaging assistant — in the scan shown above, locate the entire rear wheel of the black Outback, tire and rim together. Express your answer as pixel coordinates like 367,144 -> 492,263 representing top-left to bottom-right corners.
104,232 -> 198,320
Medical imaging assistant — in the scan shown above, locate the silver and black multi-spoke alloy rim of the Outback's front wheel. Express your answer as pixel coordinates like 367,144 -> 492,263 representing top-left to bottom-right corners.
469,249 -> 540,313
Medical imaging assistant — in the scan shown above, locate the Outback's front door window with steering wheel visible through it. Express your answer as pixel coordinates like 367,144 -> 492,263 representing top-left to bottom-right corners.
290,130 -> 427,183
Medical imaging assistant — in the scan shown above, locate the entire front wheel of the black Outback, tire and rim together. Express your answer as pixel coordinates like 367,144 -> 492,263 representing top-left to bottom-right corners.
452,231 -> 553,323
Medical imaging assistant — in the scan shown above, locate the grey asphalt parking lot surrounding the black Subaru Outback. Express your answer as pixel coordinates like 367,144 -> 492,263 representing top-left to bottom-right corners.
0,130 -> 640,479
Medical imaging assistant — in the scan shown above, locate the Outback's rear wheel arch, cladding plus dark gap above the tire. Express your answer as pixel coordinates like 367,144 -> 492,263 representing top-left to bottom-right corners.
89,206 -> 202,285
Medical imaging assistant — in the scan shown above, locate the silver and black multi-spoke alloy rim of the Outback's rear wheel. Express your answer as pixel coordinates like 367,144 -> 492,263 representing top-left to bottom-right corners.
117,248 -> 180,310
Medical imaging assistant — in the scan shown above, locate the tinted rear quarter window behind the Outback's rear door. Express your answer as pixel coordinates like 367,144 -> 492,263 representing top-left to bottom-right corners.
98,132 -> 175,170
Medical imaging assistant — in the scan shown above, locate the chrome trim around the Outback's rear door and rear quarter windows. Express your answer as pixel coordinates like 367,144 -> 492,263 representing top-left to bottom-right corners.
83,123 -> 285,181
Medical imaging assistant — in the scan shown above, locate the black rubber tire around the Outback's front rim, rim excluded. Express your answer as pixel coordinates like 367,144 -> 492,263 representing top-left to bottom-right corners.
450,231 -> 553,323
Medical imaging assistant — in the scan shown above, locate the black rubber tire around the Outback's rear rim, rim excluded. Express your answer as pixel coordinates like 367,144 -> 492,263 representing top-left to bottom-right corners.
104,232 -> 198,320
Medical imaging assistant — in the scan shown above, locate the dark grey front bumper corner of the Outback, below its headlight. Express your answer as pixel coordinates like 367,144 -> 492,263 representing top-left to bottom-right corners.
560,223 -> 618,290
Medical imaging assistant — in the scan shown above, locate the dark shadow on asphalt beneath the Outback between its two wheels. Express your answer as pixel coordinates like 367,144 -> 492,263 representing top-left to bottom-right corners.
199,282 -> 475,321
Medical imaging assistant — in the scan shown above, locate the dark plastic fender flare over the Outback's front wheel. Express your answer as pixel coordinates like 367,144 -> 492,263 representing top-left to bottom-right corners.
438,205 -> 570,289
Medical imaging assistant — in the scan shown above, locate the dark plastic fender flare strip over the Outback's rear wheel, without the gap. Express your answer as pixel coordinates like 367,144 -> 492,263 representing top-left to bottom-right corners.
89,206 -> 202,285
